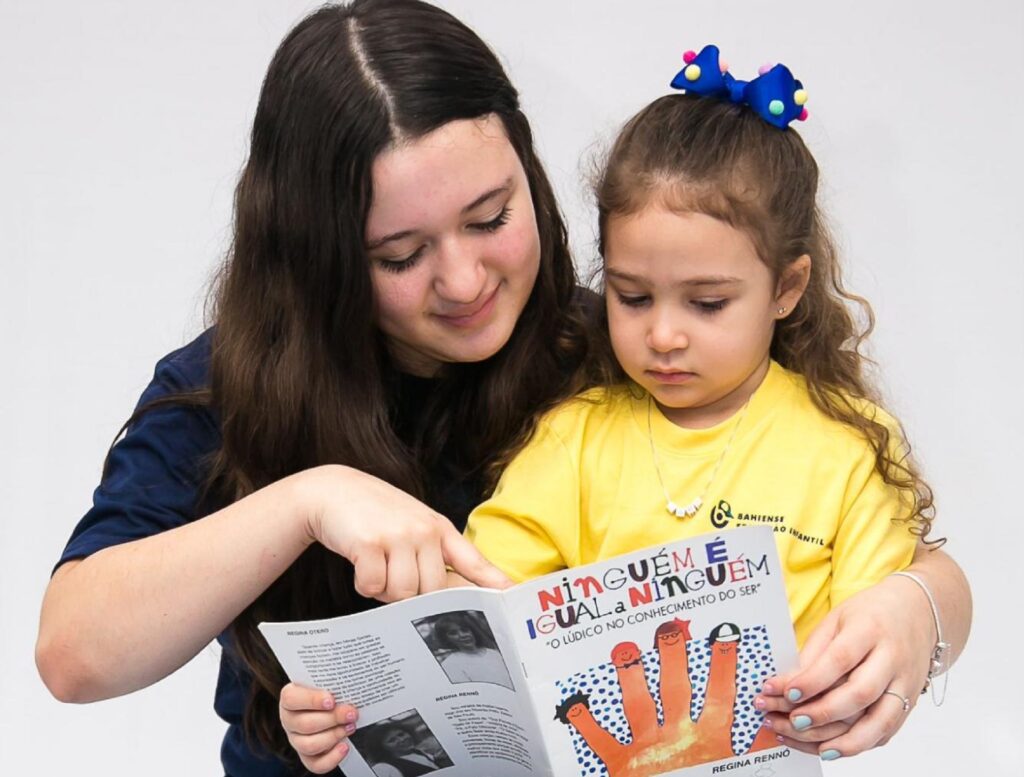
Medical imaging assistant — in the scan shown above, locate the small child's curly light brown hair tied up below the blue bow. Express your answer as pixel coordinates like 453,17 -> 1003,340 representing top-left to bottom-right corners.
595,94 -> 941,542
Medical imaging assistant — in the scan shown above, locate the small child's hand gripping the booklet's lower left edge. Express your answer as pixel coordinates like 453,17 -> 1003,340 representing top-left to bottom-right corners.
279,683 -> 358,774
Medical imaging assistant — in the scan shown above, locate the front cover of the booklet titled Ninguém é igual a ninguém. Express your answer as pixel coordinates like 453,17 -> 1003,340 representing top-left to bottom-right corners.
504,526 -> 821,777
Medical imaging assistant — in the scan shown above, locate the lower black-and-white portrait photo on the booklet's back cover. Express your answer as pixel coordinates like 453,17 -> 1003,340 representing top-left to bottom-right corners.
351,709 -> 452,777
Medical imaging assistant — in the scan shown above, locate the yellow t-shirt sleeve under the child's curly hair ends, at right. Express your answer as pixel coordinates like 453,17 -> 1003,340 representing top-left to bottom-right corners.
830,411 -> 918,607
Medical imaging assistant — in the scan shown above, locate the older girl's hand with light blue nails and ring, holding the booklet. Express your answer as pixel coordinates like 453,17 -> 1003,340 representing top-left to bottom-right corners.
755,576 -> 936,760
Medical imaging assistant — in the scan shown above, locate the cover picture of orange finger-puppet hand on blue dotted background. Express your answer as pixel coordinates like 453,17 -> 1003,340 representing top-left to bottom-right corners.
555,618 -> 778,777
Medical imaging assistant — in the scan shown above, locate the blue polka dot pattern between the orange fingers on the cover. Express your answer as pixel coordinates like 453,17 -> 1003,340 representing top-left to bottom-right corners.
555,625 -> 775,775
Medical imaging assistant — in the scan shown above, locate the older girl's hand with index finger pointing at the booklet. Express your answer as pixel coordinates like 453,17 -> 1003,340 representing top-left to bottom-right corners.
303,465 -> 511,602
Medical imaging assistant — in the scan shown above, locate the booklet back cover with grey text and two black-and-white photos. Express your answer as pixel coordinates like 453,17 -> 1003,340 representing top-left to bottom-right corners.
260,589 -> 551,777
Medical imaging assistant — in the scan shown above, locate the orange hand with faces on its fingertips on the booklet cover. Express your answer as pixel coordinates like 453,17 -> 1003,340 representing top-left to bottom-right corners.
556,618 -> 778,777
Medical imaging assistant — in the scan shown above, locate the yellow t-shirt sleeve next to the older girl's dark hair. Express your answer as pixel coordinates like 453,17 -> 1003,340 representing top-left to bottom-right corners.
466,421 -> 580,582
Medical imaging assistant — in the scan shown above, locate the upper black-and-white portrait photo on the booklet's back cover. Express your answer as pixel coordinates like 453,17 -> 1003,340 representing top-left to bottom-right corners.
413,610 -> 515,691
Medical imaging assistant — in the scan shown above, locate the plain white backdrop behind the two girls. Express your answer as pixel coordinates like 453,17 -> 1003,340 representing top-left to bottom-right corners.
0,0 -> 1024,776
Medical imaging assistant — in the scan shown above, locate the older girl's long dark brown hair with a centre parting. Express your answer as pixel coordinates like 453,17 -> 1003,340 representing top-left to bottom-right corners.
172,0 -> 586,763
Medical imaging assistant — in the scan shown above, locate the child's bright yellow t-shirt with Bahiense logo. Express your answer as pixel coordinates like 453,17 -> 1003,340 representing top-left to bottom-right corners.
466,362 -> 915,644
